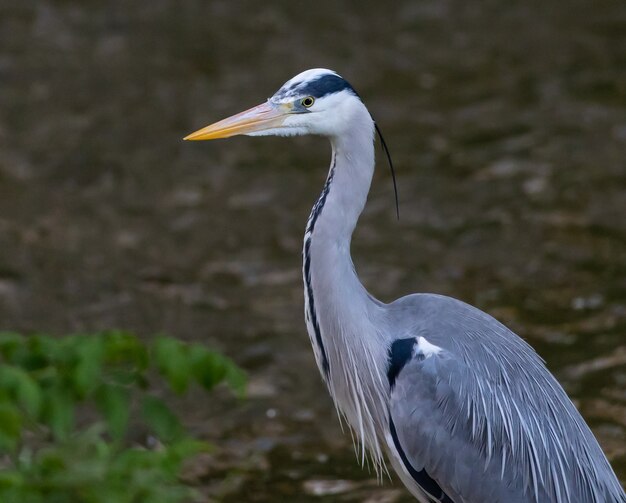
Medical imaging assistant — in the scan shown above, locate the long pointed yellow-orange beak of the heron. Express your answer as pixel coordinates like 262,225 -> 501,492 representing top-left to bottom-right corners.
183,101 -> 291,140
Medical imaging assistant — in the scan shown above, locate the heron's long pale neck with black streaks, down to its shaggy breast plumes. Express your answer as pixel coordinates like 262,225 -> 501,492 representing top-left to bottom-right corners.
303,114 -> 387,465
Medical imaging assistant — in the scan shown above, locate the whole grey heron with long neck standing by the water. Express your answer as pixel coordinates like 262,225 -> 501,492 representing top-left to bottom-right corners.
185,69 -> 626,503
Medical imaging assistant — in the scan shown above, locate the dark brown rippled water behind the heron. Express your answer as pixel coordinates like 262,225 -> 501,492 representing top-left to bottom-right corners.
0,0 -> 626,503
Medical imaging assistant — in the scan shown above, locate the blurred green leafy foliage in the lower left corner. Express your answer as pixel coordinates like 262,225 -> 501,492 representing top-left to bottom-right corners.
0,331 -> 245,503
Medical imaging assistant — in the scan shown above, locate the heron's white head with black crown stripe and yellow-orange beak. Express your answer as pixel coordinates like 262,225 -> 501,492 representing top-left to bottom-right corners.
185,68 -> 369,140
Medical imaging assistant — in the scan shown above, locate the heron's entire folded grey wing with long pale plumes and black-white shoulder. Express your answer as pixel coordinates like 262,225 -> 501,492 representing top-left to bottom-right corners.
389,334 -> 625,503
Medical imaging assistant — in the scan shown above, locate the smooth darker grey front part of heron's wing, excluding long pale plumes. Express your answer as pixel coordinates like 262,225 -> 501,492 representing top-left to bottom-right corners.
390,351 -> 534,503
